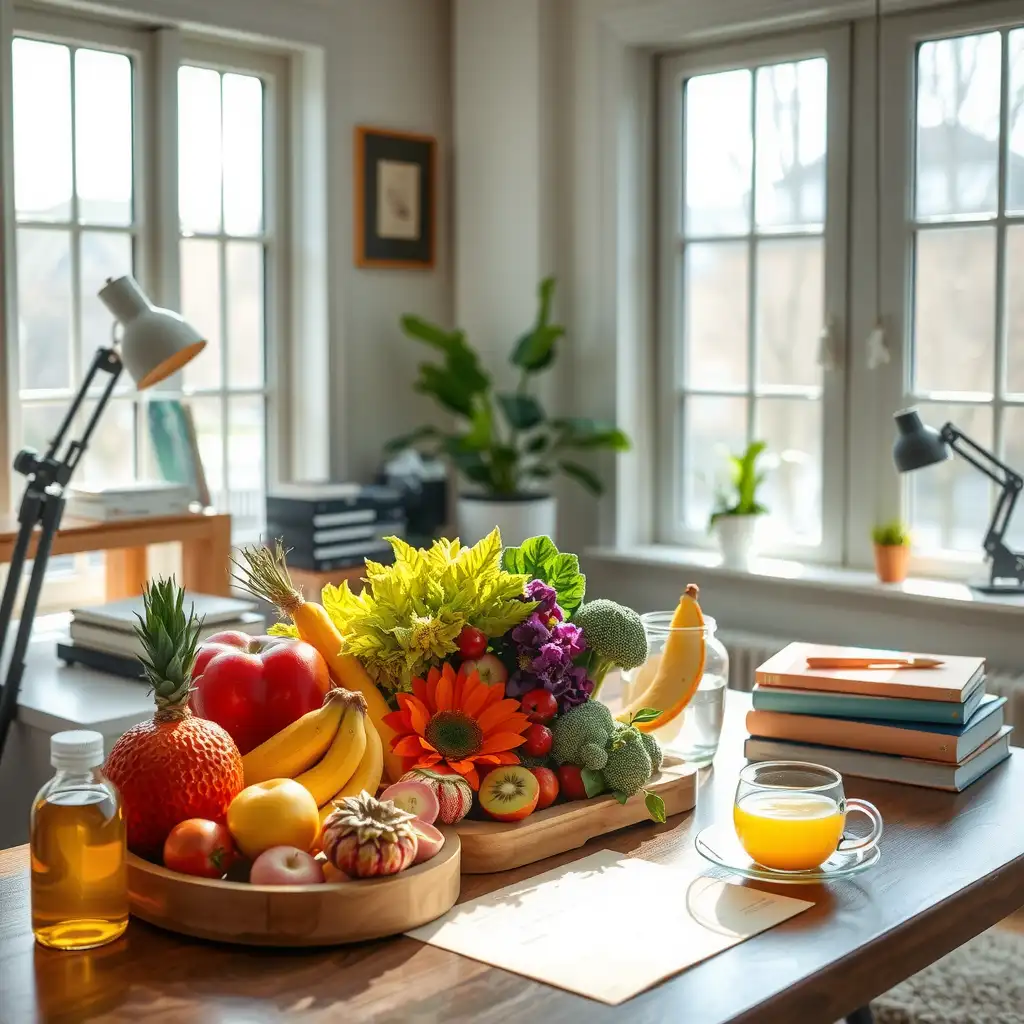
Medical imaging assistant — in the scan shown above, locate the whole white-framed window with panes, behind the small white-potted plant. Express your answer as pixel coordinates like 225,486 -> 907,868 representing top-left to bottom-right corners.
657,29 -> 850,558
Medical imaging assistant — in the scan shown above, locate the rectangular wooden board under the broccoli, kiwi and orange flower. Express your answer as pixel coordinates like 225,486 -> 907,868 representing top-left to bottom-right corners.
452,757 -> 697,874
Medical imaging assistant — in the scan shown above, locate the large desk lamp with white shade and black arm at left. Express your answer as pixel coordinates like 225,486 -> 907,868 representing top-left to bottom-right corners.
0,274 -> 206,758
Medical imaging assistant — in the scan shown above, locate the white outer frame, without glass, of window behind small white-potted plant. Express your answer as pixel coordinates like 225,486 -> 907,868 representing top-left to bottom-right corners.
655,26 -> 851,562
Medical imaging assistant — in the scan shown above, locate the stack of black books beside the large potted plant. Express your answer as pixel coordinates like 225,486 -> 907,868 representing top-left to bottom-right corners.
266,483 -> 406,572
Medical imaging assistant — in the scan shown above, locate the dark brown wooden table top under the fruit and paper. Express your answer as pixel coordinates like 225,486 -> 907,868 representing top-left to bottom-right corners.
0,692 -> 1024,1024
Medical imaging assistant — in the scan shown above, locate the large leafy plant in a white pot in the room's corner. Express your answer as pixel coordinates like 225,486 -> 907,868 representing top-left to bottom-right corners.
387,278 -> 630,545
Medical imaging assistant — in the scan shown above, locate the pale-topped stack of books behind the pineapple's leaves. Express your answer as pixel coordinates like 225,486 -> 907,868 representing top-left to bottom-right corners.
57,593 -> 265,679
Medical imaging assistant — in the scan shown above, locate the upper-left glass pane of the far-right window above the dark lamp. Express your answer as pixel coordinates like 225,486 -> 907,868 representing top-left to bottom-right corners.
916,32 -> 1001,218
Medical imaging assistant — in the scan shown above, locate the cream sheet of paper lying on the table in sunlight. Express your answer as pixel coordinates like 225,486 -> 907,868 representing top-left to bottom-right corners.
408,850 -> 813,1006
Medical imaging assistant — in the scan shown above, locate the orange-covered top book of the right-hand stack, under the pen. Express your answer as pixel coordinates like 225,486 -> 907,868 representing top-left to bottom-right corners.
756,643 -> 985,702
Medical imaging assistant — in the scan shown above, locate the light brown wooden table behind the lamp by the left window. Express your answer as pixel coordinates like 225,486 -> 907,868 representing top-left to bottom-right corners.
0,512 -> 231,601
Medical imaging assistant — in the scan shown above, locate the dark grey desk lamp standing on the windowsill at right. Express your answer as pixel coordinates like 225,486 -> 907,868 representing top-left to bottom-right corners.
893,409 -> 1024,594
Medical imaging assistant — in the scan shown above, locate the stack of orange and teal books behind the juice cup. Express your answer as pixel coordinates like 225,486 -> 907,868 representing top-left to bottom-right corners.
743,643 -> 1013,793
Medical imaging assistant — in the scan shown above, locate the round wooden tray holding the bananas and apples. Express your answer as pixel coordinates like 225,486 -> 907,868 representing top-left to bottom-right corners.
128,829 -> 462,946
